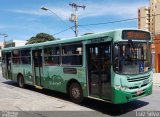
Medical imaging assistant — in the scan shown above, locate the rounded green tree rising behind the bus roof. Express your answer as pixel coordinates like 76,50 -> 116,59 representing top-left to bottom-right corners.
26,33 -> 56,45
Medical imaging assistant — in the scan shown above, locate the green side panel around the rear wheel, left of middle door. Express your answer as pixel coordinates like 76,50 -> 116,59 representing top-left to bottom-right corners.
12,64 -> 33,85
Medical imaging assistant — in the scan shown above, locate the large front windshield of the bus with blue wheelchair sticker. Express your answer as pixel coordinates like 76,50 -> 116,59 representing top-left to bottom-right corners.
113,42 -> 151,74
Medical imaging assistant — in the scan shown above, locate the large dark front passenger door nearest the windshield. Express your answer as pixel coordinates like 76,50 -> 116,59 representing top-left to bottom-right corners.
86,42 -> 111,100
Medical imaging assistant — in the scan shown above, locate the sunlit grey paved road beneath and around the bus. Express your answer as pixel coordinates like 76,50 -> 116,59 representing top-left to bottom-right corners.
0,69 -> 160,117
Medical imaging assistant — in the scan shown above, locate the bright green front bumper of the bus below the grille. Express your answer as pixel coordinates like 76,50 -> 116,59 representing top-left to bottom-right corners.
112,83 -> 153,104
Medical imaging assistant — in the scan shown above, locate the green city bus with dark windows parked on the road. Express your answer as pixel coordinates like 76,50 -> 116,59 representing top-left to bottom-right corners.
2,29 -> 153,104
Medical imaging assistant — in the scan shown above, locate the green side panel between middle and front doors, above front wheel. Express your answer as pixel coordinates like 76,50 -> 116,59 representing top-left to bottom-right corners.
42,66 -> 86,95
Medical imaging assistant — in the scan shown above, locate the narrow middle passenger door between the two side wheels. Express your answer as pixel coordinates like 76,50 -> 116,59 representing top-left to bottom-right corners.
32,49 -> 43,86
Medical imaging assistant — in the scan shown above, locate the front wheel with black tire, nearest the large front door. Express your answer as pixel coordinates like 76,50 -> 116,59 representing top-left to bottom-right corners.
69,82 -> 83,103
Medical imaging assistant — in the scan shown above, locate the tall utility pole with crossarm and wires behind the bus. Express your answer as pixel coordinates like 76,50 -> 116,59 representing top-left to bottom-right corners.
69,3 -> 86,37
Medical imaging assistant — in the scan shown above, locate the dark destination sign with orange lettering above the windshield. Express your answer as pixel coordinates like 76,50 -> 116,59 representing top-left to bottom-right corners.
122,30 -> 150,40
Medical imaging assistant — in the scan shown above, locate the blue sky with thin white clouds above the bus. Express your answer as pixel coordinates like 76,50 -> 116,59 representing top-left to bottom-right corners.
0,0 -> 149,41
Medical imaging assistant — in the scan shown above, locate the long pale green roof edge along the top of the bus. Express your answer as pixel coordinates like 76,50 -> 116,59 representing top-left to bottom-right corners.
2,28 -> 148,50
